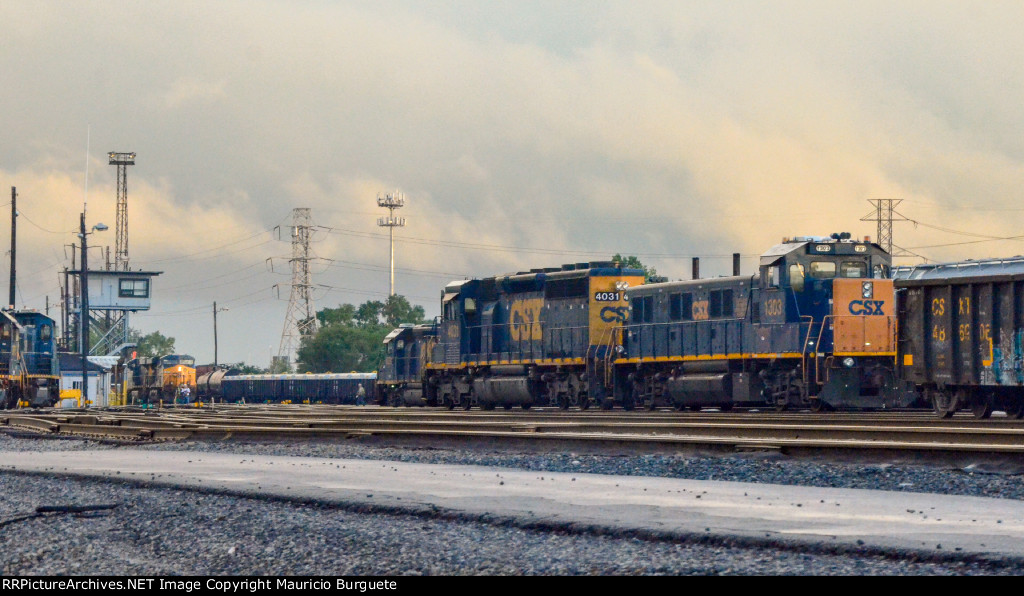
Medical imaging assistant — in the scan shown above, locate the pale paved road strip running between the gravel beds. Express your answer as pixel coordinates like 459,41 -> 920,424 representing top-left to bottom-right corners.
0,450 -> 1024,560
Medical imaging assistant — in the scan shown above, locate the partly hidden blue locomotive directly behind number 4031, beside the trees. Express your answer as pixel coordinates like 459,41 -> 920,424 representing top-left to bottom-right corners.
377,323 -> 437,407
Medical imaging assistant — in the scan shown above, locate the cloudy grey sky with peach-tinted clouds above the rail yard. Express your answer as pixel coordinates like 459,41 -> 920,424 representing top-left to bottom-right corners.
0,0 -> 1024,366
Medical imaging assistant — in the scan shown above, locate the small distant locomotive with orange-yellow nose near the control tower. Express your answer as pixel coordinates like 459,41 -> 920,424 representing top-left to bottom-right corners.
125,354 -> 198,403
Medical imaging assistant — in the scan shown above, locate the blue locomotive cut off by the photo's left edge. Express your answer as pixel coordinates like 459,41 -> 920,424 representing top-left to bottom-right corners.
0,310 -> 60,409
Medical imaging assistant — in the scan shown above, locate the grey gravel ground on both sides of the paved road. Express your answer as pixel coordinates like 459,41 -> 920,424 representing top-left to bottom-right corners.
0,433 -> 1024,576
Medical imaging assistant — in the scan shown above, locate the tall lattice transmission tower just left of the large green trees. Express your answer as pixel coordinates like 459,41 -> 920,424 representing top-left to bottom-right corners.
278,207 -> 317,363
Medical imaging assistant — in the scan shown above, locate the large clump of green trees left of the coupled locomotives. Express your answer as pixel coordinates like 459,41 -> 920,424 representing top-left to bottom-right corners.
297,295 -> 426,373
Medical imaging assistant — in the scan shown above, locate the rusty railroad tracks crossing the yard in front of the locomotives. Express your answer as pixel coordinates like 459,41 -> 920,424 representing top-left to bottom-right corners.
6,405 -> 1024,456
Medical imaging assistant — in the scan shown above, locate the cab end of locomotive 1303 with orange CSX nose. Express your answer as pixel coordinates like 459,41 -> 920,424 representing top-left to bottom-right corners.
760,233 -> 904,409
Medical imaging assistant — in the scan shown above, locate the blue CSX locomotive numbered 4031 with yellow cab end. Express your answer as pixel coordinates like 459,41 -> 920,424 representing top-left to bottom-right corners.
423,262 -> 644,410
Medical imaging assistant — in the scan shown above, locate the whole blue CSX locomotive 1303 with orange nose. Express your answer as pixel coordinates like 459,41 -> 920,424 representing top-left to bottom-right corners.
612,233 -> 913,410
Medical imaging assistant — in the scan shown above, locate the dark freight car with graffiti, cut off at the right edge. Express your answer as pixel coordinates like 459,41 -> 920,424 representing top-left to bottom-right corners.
893,257 -> 1024,419
